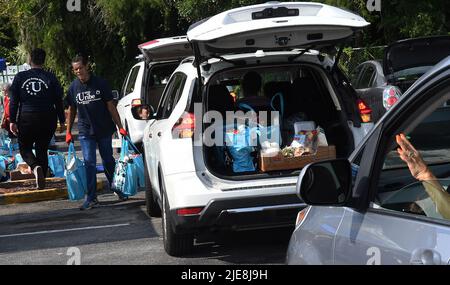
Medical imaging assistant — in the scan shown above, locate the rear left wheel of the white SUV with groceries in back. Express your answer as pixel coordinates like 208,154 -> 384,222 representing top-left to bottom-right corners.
161,175 -> 194,256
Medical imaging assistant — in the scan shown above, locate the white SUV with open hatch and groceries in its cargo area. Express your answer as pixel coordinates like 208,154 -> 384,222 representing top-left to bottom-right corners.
134,2 -> 373,256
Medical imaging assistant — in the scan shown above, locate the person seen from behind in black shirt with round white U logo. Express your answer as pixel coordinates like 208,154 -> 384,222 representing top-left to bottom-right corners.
9,49 -> 65,189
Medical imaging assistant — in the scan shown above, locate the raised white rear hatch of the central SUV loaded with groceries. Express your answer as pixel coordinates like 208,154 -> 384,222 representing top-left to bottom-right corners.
187,2 -> 370,63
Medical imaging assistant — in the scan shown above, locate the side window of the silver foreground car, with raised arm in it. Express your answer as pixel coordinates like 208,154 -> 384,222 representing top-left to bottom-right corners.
373,90 -> 450,220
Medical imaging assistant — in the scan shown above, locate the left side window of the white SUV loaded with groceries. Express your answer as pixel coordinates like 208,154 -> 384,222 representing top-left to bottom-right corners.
158,73 -> 187,119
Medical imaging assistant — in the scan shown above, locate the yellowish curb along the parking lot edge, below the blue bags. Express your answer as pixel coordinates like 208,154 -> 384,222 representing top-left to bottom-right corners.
0,180 -> 105,205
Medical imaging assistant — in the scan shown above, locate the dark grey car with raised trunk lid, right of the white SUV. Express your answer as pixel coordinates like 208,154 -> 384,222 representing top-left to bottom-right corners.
350,36 -> 450,122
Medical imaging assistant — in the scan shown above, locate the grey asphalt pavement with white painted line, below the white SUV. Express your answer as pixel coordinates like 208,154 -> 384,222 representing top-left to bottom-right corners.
0,189 -> 292,265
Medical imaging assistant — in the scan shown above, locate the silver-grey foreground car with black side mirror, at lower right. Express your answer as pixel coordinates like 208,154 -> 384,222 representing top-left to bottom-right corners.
287,56 -> 450,264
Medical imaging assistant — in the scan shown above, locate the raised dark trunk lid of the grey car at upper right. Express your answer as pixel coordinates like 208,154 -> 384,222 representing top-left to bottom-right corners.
383,36 -> 450,84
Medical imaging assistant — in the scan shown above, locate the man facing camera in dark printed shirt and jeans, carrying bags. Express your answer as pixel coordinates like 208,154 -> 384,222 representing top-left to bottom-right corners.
66,55 -> 128,210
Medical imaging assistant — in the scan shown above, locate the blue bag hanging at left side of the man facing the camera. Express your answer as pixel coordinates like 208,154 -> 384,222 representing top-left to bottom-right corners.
66,143 -> 87,200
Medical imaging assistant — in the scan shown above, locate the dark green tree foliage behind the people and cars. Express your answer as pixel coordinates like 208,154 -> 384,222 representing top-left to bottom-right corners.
0,0 -> 450,92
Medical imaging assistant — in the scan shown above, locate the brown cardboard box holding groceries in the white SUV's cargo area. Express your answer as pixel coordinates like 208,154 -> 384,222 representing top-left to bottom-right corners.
258,145 -> 336,172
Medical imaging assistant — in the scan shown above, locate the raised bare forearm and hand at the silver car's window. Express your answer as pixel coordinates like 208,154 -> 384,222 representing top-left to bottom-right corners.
396,134 -> 450,219
